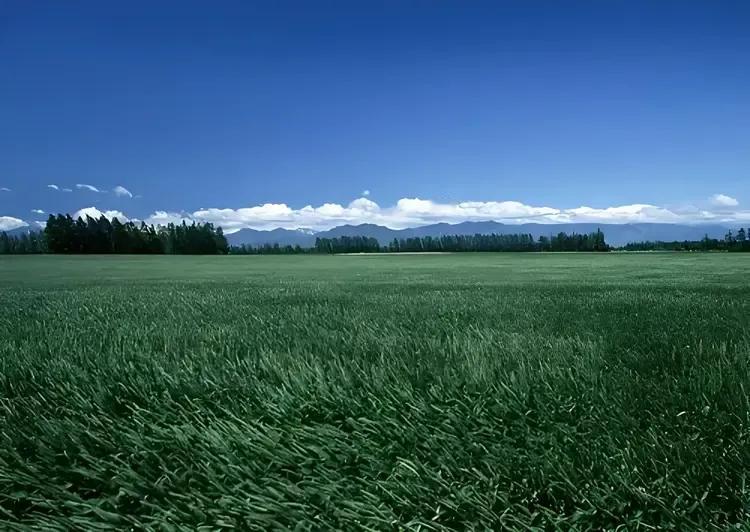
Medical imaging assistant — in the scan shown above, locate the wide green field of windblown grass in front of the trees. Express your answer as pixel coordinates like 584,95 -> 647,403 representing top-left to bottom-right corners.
0,254 -> 750,530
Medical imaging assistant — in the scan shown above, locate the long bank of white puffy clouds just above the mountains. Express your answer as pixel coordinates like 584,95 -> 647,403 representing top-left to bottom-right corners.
0,194 -> 750,233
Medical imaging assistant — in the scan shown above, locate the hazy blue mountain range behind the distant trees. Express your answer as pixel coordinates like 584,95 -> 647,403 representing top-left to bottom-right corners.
227,222 -> 734,247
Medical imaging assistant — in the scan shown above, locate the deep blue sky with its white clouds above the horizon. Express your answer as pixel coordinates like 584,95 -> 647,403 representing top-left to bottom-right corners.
0,0 -> 750,228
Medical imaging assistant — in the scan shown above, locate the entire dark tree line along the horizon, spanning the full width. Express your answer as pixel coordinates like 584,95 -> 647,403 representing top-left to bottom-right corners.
0,214 -> 750,255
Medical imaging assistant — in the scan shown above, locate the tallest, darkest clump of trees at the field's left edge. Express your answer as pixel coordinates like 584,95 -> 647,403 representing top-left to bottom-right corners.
0,214 -> 229,255
